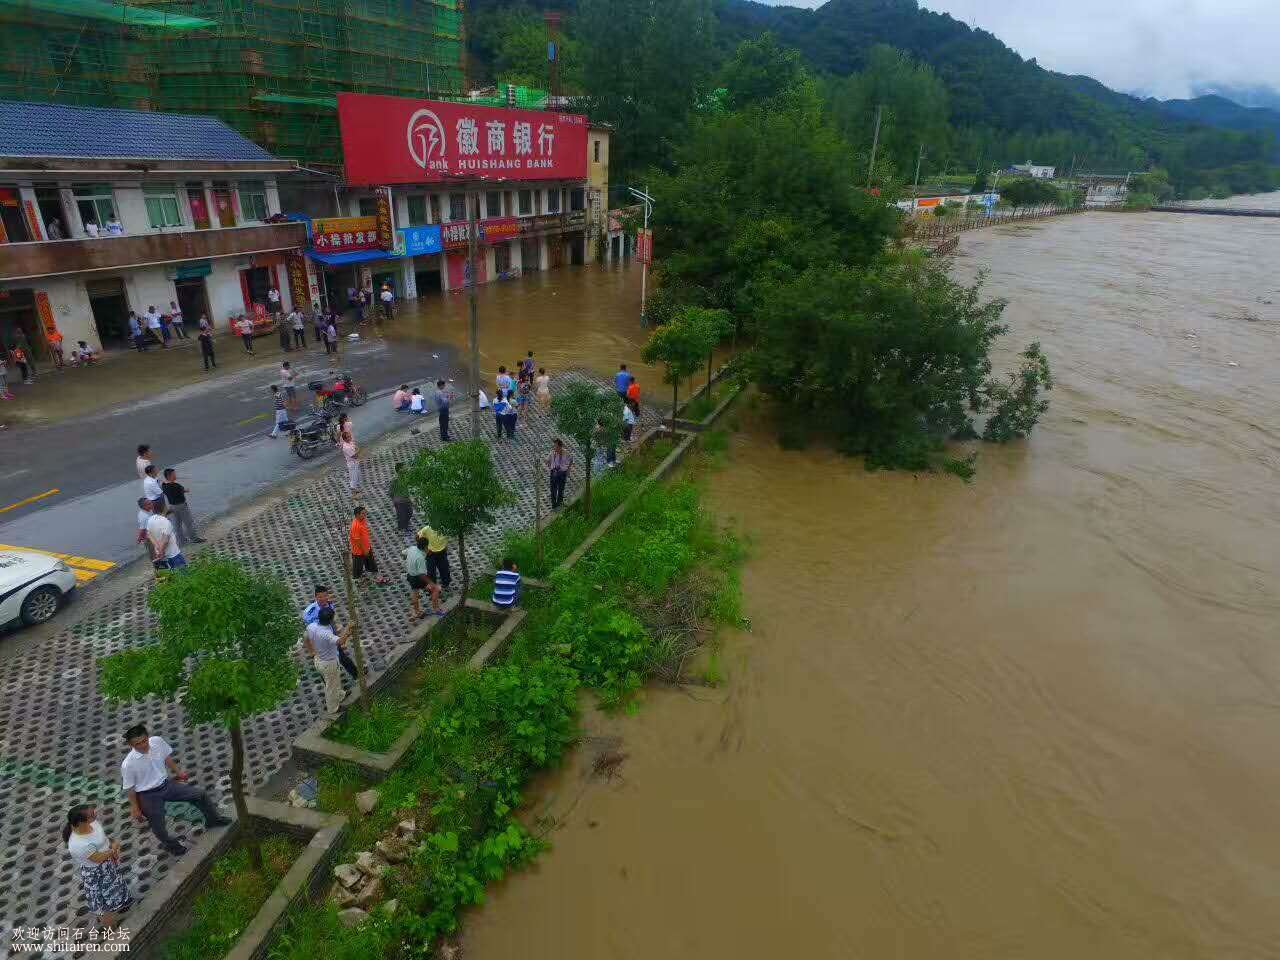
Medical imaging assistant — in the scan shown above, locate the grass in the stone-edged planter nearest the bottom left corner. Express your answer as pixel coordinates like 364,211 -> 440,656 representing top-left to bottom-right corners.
160,836 -> 303,960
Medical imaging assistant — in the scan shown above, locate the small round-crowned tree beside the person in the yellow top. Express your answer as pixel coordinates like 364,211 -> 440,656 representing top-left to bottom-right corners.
396,440 -> 515,604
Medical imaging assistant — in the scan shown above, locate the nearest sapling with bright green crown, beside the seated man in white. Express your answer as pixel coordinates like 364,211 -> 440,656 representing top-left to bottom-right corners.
101,557 -> 298,870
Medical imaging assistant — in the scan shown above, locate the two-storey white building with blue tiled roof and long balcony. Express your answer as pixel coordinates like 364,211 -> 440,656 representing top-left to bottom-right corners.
0,100 -> 314,357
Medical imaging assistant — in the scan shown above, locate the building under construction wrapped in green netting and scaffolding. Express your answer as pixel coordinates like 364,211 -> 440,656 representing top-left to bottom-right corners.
0,0 -> 465,168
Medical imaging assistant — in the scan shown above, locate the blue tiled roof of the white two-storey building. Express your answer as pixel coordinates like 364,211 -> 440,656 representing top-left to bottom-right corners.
0,100 -> 275,161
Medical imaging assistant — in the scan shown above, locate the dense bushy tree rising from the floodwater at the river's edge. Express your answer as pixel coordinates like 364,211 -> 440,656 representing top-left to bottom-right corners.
750,255 -> 1029,470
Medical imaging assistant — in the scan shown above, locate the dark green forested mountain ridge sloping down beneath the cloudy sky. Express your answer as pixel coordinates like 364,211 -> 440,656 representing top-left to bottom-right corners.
468,0 -> 1280,193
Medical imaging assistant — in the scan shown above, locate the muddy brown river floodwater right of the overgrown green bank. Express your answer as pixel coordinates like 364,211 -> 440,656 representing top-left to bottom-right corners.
467,195 -> 1280,960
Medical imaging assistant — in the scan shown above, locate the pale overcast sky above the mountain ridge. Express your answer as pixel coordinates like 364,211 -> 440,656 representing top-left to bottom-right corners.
764,0 -> 1280,99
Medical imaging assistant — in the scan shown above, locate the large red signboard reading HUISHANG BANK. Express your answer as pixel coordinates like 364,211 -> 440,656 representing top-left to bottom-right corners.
338,93 -> 588,186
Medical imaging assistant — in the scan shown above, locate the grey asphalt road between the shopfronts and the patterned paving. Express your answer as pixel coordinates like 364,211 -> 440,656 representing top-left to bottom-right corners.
0,340 -> 463,580
